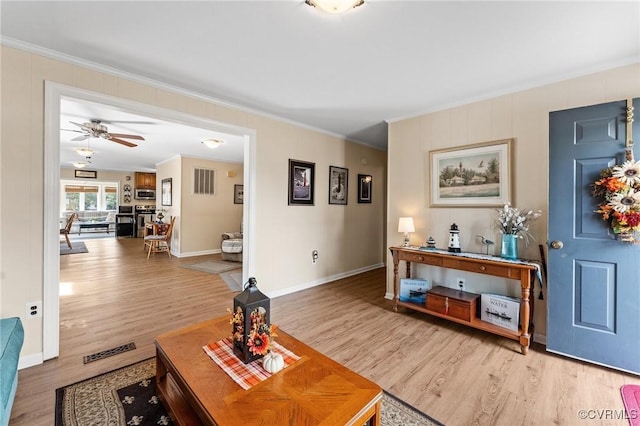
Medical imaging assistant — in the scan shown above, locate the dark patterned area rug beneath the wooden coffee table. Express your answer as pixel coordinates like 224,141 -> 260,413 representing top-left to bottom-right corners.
55,358 -> 442,426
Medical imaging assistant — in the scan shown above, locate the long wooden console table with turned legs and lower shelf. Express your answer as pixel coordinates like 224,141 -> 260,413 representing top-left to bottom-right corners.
389,247 -> 538,355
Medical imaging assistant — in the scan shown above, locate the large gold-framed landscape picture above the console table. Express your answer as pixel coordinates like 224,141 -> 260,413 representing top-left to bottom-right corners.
428,139 -> 513,207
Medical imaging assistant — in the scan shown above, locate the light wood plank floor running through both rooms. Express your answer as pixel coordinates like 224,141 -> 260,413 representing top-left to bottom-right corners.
10,238 -> 640,426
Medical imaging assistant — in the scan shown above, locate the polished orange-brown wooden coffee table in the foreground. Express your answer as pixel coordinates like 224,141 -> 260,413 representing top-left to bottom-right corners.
155,316 -> 382,426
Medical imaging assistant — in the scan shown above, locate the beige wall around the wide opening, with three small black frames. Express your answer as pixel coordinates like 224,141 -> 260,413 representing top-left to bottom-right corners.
0,46 -> 386,359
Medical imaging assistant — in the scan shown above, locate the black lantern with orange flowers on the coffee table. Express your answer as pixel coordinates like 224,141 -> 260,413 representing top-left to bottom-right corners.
233,277 -> 271,364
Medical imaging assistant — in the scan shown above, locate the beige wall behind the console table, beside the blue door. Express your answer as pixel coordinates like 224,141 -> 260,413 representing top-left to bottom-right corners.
387,64 -> 640,335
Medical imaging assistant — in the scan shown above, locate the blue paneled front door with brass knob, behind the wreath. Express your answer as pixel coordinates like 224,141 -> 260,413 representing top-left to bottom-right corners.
547,99 -> 640,374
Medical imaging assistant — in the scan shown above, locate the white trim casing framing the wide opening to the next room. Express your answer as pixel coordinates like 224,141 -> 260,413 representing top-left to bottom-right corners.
43,82 -> 256,360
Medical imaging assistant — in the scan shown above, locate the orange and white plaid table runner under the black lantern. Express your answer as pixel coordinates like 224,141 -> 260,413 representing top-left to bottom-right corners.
202,337 -> 300,390
